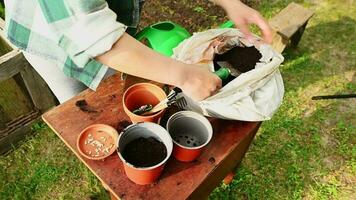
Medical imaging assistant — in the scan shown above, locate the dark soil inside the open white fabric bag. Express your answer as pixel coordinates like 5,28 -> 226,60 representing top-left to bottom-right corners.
214,46 -> 262,73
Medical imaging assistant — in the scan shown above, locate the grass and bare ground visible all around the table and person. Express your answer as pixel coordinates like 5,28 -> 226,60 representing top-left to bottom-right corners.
0,0 -> 356,199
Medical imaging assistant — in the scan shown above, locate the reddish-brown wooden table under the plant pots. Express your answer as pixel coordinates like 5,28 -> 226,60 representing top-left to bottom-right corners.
43,75 -> 260,200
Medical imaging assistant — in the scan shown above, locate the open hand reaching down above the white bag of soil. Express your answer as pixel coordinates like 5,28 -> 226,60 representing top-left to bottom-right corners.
214,0 -> 272,44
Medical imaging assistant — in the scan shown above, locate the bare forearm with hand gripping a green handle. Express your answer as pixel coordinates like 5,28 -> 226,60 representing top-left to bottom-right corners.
96,33 -> 222,101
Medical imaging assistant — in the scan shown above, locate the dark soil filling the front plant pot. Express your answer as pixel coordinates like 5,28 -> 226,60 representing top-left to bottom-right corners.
122,137 -> 167,167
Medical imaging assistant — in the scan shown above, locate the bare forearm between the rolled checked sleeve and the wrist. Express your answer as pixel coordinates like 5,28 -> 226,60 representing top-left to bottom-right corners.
96,33 -> 187,86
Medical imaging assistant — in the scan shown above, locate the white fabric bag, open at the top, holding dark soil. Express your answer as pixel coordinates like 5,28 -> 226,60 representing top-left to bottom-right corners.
172,28 -> 284,121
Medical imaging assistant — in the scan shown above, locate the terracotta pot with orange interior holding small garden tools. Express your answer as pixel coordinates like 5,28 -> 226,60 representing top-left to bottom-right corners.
122,83 -> 167,123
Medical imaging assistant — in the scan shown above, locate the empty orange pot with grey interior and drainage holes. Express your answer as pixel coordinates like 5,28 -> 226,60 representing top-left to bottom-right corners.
167,111 -> 213,162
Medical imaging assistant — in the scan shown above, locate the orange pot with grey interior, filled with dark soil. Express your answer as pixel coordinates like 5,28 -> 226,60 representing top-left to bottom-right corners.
117,122 -> 173,185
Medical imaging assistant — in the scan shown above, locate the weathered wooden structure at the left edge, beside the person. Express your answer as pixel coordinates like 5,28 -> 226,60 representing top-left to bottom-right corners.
0,18 -> 56,154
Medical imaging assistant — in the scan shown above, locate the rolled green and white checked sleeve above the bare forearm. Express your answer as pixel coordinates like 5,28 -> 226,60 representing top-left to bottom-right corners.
38,0 -> 127,67
